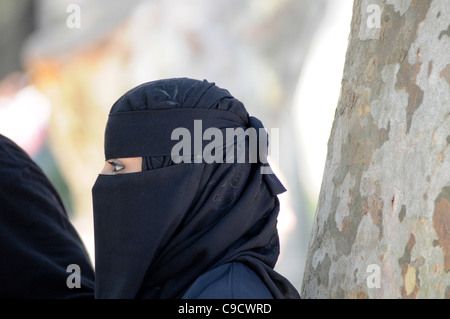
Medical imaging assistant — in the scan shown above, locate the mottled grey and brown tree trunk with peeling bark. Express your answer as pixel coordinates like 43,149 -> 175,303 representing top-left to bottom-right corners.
302,0 -> 450,298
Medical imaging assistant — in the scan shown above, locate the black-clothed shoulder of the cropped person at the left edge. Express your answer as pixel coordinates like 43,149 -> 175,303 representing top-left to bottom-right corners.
0,135 -> 94,299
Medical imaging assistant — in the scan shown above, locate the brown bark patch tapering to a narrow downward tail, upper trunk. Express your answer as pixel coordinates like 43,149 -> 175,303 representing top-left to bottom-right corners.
395,63 -> 423,133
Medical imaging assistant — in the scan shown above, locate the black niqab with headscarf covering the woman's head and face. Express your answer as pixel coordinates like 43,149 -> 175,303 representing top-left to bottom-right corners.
93,78 -> 299,298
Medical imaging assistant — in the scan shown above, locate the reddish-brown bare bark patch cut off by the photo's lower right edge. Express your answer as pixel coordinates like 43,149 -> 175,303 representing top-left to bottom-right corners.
433,186 -> 450,272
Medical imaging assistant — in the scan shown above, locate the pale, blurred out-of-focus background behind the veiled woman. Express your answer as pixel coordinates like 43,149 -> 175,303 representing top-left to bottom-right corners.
0,0 -> 353,290
